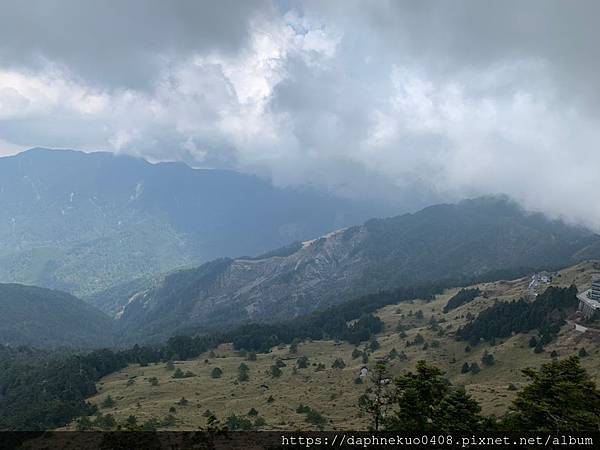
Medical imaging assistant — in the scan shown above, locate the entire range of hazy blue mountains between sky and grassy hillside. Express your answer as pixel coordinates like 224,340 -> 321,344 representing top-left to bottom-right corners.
0,149 -> 600,347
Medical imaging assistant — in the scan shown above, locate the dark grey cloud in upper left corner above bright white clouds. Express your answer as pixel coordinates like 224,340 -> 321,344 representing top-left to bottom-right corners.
0,0 -> 270,87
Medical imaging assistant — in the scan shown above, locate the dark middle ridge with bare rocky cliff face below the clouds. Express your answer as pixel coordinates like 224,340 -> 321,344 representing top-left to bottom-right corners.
111,198 -> 600,338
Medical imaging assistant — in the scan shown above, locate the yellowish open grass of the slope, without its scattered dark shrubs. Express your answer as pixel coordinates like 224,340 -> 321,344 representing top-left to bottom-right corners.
74,263 -> 600,430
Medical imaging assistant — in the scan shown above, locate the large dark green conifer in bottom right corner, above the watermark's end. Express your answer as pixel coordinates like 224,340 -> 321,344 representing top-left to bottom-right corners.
504,356 -> 600,432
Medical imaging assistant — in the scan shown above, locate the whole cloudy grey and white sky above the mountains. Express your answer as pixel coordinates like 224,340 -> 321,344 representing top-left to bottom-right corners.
0,0 -> 600,231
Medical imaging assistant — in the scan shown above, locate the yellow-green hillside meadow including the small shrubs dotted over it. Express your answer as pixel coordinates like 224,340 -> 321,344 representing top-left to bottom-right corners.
71,263 -> 600,430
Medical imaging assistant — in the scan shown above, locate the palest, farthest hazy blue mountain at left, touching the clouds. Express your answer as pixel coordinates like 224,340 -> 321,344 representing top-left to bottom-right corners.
0,148 -> 390,297
